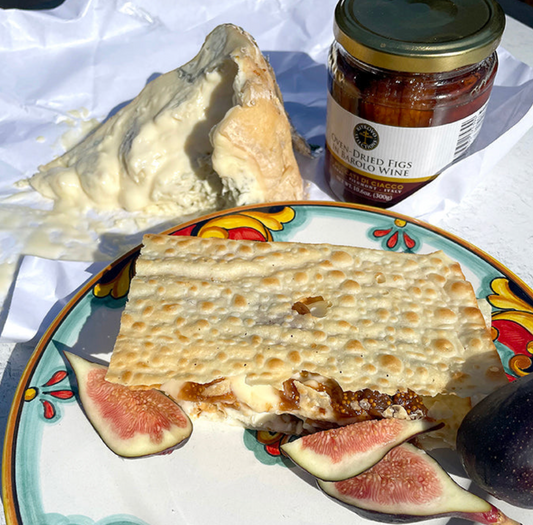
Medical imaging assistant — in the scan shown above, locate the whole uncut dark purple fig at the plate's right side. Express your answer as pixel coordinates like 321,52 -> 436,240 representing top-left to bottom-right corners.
456,374 -> 533,509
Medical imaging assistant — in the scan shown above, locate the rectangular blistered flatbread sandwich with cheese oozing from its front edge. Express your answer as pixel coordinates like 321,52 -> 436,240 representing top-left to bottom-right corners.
107,235 -> 506,438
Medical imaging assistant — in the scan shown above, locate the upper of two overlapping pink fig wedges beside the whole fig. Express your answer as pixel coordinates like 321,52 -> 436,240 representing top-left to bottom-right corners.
281,418 -> 442,481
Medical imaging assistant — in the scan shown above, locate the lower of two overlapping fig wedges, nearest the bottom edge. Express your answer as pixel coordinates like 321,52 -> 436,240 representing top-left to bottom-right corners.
318,443 -> 520,525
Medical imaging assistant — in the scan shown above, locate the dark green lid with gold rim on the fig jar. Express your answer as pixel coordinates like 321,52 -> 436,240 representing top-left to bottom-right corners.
334,0 -> 505,73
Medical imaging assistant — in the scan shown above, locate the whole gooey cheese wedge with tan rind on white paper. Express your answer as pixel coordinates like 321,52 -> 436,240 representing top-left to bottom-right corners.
30,24 -> 303,215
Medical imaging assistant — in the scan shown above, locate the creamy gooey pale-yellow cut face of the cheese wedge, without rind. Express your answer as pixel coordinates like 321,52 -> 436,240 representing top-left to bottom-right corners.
31,59 -> 237,213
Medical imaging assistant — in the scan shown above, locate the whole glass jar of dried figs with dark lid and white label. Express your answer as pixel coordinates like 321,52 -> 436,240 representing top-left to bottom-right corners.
325,0 -> 505,208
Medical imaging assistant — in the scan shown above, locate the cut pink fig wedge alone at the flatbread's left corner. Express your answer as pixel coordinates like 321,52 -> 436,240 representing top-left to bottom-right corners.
65,352 -> 192,458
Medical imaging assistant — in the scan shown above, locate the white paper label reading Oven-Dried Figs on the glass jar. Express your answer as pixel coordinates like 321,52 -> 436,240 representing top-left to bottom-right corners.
326,92 -> 486,183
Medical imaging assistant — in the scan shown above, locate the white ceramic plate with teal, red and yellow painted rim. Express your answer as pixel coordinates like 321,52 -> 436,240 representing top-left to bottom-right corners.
2,203 -> 533,525
